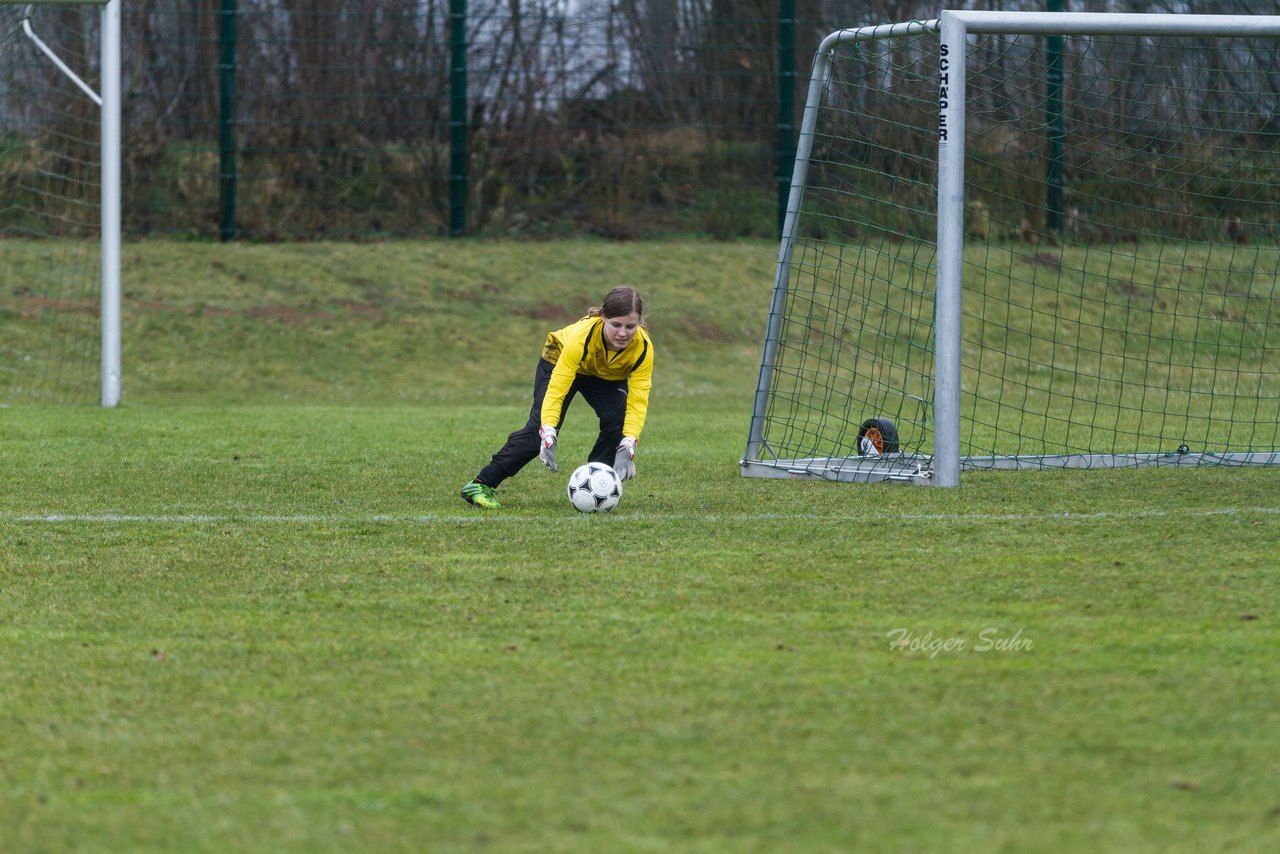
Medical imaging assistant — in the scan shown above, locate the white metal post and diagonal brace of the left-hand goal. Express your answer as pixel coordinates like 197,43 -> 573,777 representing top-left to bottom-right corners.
0,0 -> 122,407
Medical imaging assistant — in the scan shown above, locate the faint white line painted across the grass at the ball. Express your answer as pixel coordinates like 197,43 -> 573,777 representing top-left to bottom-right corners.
0,507 -> 1280,526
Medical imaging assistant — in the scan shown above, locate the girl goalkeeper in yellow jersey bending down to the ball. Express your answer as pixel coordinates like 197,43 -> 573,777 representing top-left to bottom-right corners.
462,287 -> 653,510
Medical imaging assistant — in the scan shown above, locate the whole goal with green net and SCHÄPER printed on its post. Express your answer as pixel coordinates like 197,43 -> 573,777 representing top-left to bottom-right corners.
742,13 -> 1280,485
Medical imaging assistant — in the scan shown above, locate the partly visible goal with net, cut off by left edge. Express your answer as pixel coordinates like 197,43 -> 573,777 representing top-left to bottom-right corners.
0,0 -> 119,406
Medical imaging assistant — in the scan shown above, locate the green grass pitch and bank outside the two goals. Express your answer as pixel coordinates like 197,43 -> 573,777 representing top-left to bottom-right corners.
0,236 -> 1280,851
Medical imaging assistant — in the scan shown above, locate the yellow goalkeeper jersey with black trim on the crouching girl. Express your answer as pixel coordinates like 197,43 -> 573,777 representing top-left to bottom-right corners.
543,316 -> 653,439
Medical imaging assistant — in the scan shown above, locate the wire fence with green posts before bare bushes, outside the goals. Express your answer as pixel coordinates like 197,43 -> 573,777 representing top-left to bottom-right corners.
0,0 -> 1275,239
